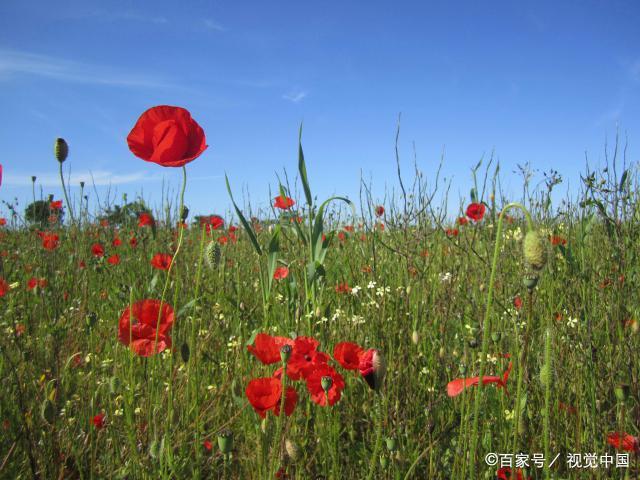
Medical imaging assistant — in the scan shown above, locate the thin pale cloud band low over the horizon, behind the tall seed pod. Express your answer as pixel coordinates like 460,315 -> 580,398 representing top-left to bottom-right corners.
2,167 -> 162,187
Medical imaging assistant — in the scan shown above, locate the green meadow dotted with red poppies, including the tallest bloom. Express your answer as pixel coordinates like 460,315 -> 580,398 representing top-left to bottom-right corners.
0,106 -> 640,479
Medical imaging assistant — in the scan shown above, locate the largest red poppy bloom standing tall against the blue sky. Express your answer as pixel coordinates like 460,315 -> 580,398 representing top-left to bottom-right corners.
127,105 -> 207,167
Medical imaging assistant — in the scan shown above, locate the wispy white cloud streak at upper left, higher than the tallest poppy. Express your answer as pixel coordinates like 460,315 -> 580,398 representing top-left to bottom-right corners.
0,49 -> 173,88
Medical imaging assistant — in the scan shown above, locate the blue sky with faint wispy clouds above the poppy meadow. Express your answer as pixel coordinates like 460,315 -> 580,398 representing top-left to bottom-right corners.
0,0 -> 640,218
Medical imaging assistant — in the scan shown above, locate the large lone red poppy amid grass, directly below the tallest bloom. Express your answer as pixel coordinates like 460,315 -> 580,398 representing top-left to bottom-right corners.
118,300 -> 174,357
